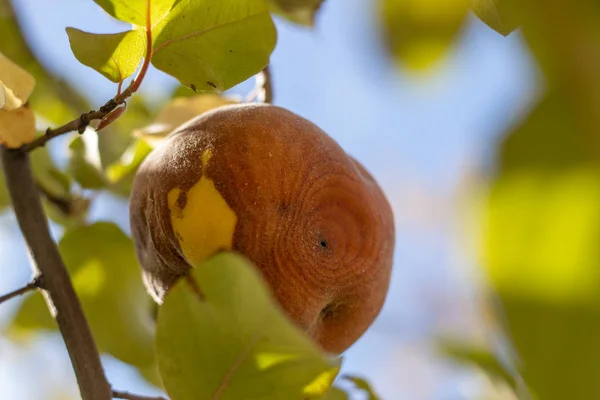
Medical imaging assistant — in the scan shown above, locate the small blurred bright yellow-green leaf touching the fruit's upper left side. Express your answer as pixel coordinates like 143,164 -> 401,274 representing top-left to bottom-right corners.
106,140 -> 152,197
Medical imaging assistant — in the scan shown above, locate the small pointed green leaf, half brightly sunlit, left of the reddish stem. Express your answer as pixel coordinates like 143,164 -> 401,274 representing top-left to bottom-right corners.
67,28 -> 146,83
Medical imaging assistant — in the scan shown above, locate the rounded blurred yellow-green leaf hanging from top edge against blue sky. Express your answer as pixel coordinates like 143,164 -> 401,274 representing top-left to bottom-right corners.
380,0 -> 469,71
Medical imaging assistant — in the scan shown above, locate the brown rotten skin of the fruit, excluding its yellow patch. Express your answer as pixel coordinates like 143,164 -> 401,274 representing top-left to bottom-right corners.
130,104 -> 395,354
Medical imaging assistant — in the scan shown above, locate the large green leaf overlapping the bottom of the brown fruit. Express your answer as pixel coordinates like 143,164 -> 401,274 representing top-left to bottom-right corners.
156,253 -> 339,400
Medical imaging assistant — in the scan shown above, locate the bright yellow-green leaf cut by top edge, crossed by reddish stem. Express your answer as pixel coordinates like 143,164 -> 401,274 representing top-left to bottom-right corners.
94,0 -> 177,27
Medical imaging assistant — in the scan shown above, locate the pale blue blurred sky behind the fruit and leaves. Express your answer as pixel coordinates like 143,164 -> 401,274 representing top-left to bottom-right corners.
0,0 -> 537,400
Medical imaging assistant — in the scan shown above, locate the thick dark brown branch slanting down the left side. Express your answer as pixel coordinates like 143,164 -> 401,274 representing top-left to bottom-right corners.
0,146 -> 112,400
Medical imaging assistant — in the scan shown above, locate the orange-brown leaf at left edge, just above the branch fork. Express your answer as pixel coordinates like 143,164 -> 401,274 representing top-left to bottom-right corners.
0,104 -> 35,148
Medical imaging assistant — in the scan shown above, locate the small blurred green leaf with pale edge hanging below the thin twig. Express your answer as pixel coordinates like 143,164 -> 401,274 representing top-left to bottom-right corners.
68,136 -> 107,189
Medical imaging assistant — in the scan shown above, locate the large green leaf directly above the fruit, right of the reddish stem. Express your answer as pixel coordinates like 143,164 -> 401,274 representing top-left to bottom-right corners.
152,0 -> 277,92
